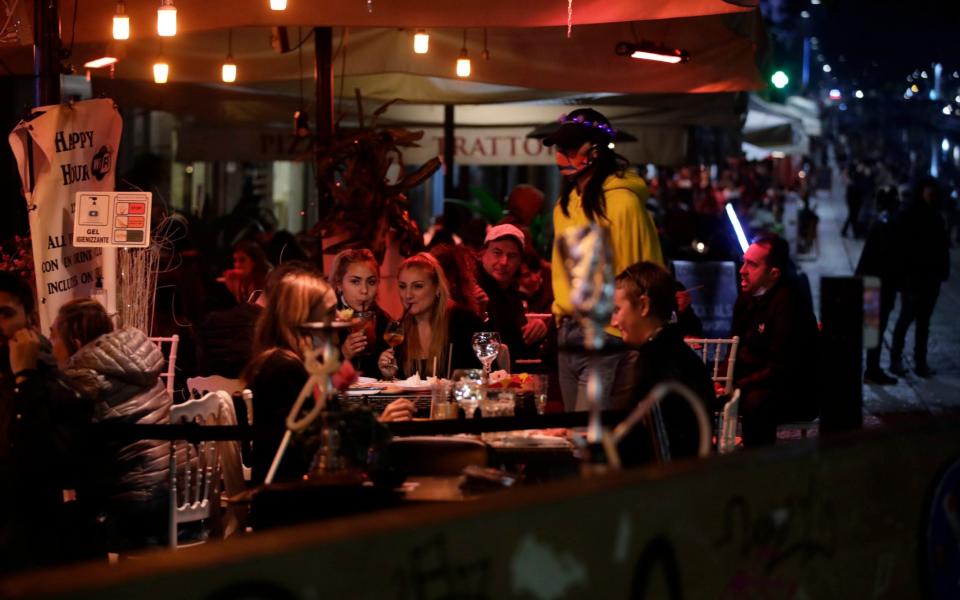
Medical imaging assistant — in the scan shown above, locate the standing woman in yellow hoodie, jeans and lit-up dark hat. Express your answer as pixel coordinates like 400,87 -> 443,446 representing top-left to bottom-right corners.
543,108 -> 663,410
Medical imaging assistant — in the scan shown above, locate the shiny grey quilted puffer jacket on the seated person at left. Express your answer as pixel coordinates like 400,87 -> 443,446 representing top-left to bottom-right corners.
64,328 -> 171,502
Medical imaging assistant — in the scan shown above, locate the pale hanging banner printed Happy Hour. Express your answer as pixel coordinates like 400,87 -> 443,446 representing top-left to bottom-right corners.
9,99 -> 123,332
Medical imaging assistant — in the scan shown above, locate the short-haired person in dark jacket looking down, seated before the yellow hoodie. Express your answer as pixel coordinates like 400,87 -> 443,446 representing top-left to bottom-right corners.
611,262 -> 715,464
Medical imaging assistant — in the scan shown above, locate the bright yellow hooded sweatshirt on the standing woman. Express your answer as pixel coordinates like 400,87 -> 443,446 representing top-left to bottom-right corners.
551,171 -> 663,337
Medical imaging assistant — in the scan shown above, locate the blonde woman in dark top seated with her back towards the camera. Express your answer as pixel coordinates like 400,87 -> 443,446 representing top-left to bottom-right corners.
243,263 -> 416,481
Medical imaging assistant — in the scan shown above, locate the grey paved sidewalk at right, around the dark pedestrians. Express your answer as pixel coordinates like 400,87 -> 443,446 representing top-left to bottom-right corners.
799,177 -> 960,427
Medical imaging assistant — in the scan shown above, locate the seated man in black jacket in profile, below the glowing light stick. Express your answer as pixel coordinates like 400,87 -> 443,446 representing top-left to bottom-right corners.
732,235 -> 819,446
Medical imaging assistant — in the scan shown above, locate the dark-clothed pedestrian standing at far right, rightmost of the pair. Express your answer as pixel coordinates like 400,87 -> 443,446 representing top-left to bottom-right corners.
890,179 -> 950,377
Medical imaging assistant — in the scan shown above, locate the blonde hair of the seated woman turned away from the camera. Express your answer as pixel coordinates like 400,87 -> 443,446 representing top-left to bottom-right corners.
243,263 -> 336,382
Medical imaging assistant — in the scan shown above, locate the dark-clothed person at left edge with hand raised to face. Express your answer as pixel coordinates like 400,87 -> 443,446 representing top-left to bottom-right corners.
0,272 -> 92,571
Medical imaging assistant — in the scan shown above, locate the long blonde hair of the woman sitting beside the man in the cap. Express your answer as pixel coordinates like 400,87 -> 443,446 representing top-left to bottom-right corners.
397,252 -> 450,374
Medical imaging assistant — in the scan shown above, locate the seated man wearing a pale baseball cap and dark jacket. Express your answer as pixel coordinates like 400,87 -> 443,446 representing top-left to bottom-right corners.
477,224 -> 547,366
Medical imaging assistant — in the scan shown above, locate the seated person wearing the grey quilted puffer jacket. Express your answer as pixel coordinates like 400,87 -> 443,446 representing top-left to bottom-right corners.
50,299 -> 171,552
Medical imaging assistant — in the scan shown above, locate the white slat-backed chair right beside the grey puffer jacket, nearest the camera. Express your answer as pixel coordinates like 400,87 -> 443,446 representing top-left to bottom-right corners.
170,392 -> 231,549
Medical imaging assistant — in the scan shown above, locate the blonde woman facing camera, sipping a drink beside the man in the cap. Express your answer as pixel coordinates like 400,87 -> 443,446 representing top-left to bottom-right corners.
377,252 -> 481,378
